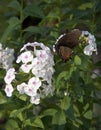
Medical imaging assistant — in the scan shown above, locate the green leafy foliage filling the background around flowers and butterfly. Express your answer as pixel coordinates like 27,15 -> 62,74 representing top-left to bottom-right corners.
0,0 -> 101,130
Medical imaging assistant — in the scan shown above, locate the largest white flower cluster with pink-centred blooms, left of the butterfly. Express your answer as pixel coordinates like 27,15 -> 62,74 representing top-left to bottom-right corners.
5,42 -> 54,104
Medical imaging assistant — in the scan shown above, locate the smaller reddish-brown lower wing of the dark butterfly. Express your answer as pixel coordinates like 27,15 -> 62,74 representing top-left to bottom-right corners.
59,46 -> 72,61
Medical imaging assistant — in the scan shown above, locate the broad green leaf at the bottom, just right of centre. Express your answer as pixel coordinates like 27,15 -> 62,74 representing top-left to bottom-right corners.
52,110 -> 66,125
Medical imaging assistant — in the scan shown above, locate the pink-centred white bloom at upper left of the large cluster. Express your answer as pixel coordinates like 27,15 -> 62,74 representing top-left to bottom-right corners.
16,51 -> 33,63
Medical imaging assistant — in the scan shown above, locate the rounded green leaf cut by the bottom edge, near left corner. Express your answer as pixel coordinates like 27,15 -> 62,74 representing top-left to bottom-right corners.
5,119 -> 19,130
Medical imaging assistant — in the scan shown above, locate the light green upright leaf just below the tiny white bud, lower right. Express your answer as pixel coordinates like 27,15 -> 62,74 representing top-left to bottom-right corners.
60,96 -> 71,110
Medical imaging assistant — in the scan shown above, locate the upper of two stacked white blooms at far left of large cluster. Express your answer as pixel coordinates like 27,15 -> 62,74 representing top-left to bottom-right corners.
4,68 -> 15,84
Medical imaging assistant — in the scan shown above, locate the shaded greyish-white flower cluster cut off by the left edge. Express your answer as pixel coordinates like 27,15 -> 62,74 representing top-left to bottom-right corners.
0,43 -> 14,70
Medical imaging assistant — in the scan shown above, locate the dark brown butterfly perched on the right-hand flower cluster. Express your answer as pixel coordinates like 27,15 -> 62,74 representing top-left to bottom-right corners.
55,29 -> 82,61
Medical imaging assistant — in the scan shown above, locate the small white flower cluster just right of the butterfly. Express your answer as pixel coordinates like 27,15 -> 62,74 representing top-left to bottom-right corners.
81,31 -> 97,56
